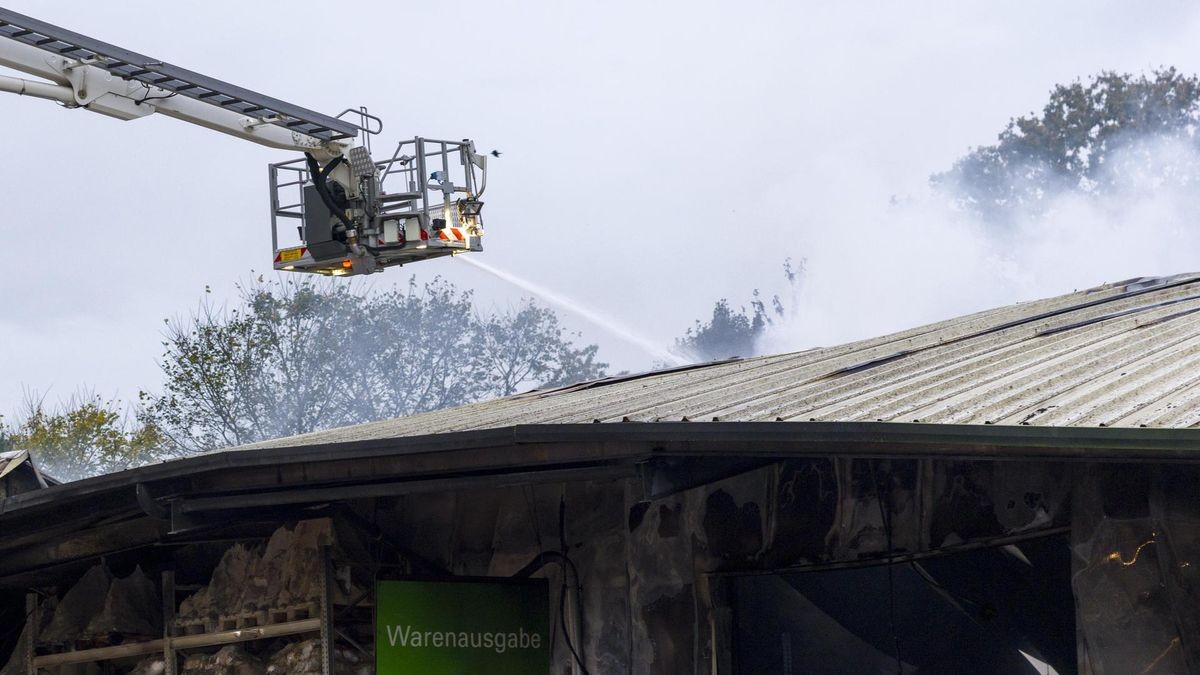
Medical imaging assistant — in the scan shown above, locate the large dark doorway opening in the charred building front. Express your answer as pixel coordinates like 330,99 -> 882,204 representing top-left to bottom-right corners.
732,533 -> 1076,675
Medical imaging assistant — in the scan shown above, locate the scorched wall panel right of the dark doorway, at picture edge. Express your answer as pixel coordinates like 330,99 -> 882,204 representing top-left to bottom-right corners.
1072,465 -> 1200,675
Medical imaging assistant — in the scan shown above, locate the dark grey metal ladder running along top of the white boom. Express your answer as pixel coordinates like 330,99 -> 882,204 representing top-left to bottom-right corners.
0,7 -> 361,141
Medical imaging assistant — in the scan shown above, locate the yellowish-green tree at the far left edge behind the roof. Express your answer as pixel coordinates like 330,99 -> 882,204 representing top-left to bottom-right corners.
0,395 -> 170,480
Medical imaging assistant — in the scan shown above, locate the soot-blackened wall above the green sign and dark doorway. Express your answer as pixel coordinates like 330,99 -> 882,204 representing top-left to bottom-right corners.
371,459 -> 1070,675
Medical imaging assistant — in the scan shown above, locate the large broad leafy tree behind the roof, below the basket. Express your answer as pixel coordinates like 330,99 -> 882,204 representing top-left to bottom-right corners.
140,277 -> 607,450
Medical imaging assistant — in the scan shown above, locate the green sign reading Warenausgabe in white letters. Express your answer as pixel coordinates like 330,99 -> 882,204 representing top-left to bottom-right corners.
376,571 -> 550,675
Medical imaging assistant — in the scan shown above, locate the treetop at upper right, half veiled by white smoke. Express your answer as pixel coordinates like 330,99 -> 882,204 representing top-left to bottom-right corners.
932,68 -> 1200,221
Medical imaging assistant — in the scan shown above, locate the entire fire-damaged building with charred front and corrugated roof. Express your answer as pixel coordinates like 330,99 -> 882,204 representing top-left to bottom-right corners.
0,275 -> 1200,675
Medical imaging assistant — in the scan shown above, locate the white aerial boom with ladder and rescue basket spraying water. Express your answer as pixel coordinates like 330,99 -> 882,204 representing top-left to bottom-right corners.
0,7 -> 487,276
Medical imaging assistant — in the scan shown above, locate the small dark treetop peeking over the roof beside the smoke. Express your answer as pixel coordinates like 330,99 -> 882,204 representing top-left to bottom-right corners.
676,259 -> 804,363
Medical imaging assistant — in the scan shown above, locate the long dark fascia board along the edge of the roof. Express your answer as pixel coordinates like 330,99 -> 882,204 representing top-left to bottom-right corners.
0,422 -> 1200,518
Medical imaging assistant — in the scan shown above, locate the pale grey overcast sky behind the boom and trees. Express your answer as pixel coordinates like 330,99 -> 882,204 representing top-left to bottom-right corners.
0,0 -> 1200,413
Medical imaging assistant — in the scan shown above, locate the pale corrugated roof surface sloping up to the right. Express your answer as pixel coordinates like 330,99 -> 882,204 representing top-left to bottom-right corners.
240,270 -> 1200,449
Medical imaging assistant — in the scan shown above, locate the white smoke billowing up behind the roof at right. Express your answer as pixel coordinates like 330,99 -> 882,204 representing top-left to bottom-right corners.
758,130 -> 1200,353
